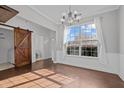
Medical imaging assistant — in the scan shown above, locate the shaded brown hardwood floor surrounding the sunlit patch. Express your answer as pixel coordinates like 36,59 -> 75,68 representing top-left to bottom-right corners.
0,59 -> 124,88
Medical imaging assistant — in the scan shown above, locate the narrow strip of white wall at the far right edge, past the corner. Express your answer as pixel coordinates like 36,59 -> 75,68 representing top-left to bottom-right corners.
119,6 -> 124,80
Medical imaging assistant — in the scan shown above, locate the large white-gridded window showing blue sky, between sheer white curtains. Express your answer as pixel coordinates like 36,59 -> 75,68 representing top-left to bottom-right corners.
65,23 -> 98,57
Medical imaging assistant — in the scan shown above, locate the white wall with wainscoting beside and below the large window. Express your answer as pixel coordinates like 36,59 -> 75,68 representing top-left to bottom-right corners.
56,10 -> 119,74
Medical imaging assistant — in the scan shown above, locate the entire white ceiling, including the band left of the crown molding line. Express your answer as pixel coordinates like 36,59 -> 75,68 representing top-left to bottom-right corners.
9,5 -> 119,31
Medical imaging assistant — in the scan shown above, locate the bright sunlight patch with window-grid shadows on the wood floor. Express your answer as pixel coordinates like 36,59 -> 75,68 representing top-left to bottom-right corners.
0,69 -> 73,88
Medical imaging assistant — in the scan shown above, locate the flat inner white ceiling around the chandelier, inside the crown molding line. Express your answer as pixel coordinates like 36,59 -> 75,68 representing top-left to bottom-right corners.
29,5 -> 119,24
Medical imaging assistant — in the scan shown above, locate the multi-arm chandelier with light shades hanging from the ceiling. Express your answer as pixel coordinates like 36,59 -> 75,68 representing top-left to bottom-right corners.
61,6 -> 82,25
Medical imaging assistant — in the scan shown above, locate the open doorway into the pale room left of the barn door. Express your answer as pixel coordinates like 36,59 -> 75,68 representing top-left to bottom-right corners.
0,27 -> 14,71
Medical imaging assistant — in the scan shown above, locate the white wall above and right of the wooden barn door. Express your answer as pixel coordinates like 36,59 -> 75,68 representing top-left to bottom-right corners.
1,16 -> 55,62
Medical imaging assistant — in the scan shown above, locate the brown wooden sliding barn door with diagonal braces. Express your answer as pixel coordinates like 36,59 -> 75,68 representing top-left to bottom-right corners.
14,28 -> 32,67
